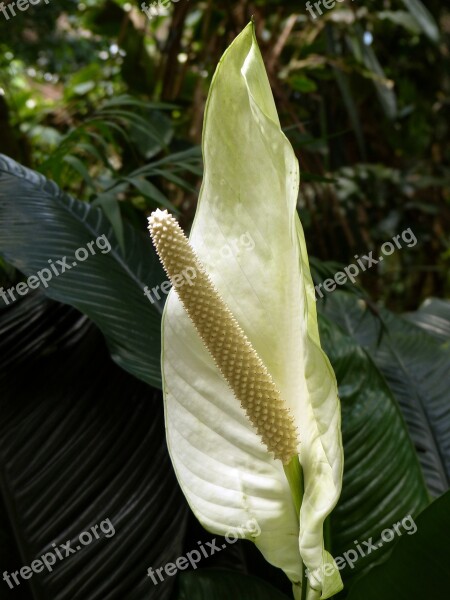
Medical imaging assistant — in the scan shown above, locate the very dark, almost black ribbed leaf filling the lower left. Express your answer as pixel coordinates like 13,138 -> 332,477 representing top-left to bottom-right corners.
0,295 -> 187,600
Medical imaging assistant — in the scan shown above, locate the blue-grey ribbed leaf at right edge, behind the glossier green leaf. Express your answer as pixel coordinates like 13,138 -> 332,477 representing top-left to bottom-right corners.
324,291 -> 450,495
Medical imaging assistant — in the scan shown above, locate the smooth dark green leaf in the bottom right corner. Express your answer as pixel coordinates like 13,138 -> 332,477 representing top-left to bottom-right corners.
348,491 -> 450,600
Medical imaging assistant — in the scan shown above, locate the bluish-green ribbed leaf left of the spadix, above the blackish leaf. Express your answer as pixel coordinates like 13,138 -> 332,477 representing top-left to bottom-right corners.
0,155 -> 164,387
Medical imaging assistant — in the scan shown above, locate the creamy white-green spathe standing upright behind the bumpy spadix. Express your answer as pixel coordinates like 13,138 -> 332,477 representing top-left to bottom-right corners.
157,25 -> 342,598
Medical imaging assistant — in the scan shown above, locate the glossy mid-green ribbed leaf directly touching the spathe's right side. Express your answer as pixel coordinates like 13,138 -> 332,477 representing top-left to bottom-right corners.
321,317 -> 428,593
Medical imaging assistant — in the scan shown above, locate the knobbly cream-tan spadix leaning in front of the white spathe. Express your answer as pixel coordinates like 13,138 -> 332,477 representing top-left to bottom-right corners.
148,210 -> 298,464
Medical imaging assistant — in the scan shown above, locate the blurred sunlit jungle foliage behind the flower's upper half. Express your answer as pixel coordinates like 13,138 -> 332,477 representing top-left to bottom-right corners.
0,0 -> 450,308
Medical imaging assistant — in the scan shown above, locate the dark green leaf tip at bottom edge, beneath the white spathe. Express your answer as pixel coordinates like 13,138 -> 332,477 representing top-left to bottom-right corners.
176,569 -> 289,600
